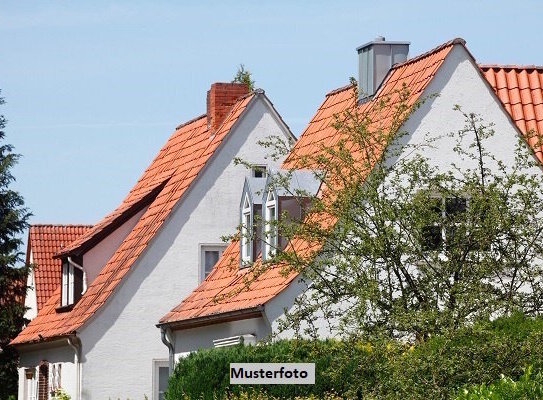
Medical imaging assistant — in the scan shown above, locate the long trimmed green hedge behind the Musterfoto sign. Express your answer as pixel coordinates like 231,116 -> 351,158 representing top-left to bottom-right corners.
166,315 -> 543,400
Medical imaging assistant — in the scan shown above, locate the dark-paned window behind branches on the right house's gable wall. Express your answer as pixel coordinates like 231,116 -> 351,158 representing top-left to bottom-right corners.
422,197 -> 467,251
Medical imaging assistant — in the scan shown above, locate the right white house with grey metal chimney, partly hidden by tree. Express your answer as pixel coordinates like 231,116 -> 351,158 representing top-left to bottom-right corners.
158,39 -> 543,359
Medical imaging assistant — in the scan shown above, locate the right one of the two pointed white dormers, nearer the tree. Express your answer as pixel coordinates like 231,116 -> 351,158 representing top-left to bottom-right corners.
262,171 -> 320,260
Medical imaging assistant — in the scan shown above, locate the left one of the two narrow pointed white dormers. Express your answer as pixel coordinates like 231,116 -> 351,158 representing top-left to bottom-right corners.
240,173 -> 266,266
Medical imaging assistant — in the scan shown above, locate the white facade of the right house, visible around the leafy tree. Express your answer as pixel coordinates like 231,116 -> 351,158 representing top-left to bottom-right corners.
168,45 -> 540,358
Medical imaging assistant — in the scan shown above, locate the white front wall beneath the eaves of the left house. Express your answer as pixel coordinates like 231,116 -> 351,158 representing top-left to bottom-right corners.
18,340 -> 77,400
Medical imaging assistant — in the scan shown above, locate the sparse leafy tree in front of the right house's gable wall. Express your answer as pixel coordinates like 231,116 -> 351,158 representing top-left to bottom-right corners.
244,87 -> 543,340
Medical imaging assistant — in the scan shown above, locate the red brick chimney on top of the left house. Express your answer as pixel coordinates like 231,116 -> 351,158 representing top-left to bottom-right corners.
207,83 -> 249,133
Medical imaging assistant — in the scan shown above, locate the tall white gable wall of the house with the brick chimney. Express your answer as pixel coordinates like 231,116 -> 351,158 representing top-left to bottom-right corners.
76,98 -> 294,400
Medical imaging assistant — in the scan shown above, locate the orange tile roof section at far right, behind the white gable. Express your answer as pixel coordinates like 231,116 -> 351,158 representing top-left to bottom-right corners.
480,65 -> 543,162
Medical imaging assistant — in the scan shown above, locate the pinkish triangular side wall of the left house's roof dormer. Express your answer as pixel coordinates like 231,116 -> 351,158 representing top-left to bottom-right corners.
83,207 -> 147,286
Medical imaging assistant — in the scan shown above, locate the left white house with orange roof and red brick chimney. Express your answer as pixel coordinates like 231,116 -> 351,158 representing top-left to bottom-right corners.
12,83 -> 293,400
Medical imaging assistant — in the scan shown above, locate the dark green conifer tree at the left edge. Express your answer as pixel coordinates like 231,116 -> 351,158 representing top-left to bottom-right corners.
0,90 -> 30,399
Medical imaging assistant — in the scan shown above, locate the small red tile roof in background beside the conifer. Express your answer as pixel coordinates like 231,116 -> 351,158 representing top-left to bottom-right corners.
26,225 -> 92,312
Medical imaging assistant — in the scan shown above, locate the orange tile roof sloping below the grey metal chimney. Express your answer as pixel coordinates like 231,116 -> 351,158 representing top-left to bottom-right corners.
159,39 -> 465,327
